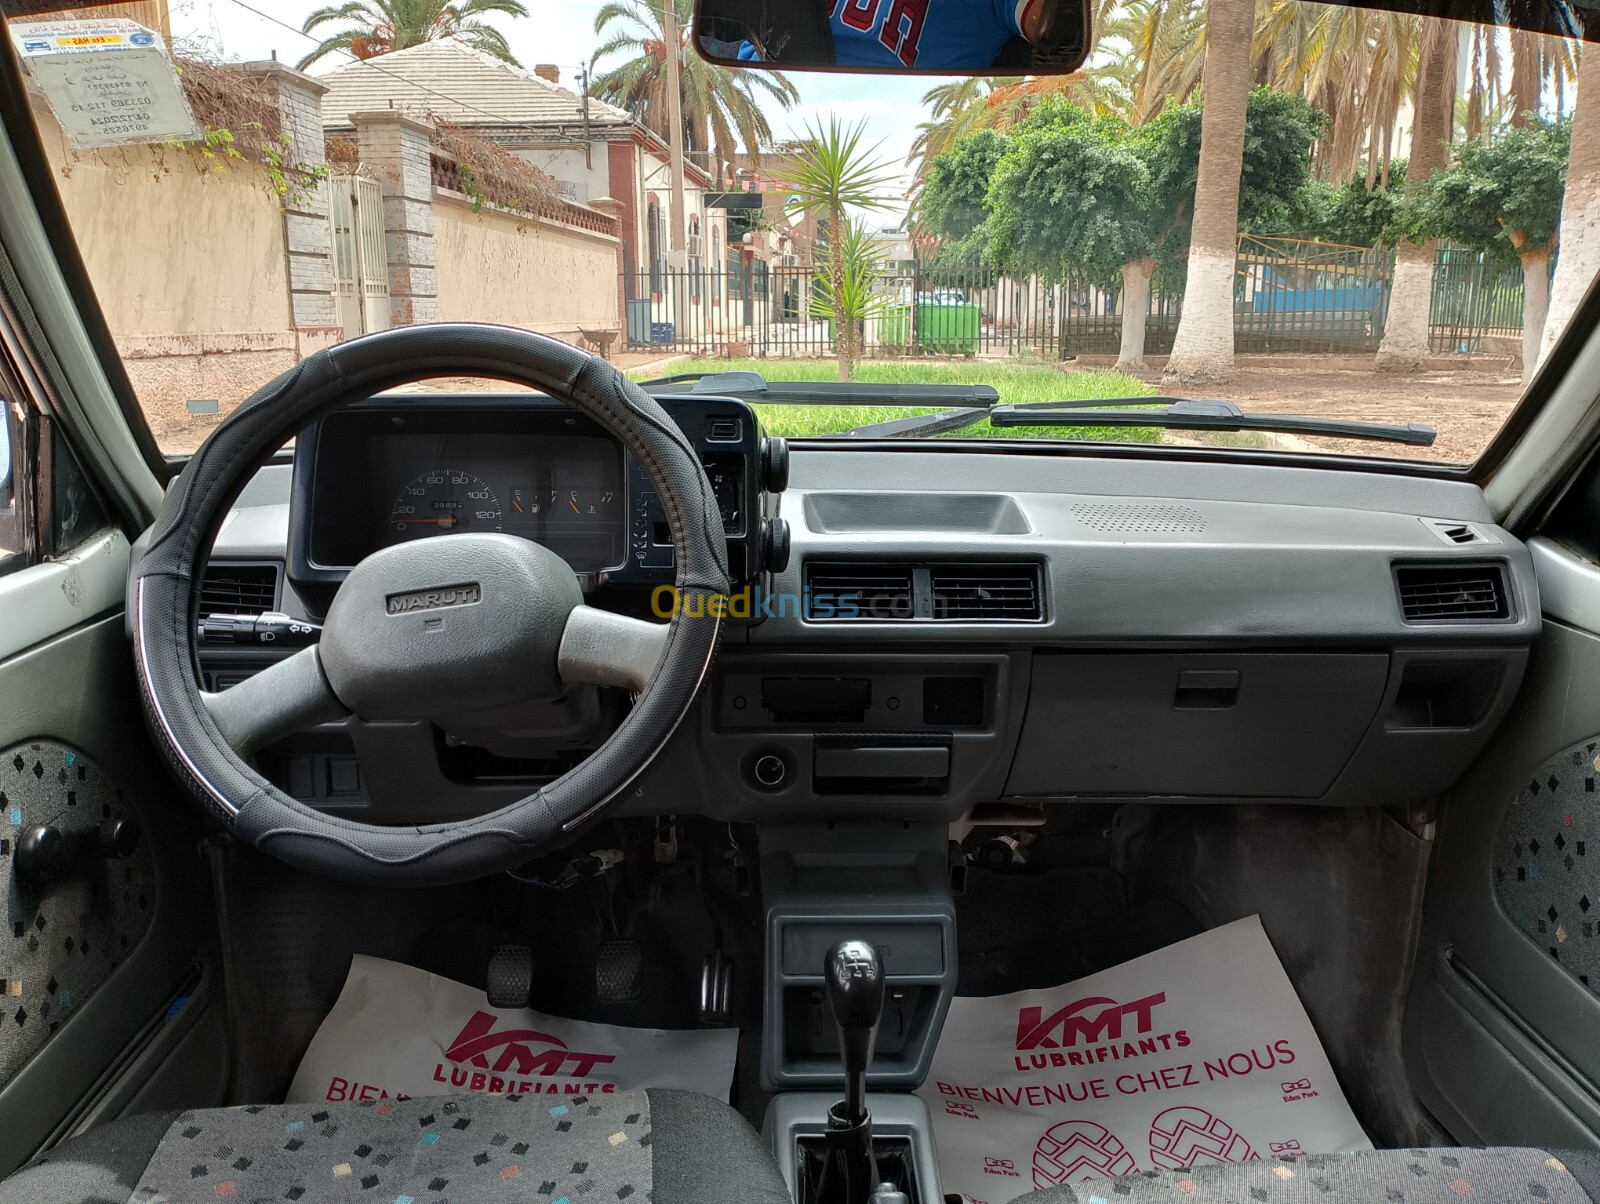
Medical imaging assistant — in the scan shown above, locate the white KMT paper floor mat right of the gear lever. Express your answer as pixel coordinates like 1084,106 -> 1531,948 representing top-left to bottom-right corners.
920,916 -> 1373,1204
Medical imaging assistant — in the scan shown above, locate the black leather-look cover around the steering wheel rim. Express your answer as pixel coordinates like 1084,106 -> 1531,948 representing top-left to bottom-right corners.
133,323 -> 728,885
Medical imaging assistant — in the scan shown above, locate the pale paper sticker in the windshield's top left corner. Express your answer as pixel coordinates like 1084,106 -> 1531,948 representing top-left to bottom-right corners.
11,18 -> 200,147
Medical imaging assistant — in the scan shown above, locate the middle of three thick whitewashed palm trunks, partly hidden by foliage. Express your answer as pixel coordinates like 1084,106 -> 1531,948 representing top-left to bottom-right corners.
1376,21 -> 1456,371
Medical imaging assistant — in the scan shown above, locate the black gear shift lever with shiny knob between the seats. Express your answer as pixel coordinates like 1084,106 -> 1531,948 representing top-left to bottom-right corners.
821,940 -> 883,1204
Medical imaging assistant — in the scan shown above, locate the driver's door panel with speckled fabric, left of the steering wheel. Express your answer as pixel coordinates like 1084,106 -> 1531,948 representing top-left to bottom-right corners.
0,602 -> 226,1174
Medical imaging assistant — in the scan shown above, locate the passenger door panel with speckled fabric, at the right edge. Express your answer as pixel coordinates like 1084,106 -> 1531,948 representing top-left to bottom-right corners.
1406,538 -> 1600,1146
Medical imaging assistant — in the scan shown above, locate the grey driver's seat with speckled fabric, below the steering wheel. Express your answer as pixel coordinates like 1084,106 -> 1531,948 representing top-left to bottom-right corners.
0,1090 -> 789,1204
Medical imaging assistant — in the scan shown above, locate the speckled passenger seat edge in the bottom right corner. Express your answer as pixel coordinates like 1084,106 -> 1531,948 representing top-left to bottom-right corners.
1021,1148 -> 1600,1204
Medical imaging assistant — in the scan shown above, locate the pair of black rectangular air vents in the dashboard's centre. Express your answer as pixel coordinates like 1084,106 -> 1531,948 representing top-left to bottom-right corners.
805,560 -> 1045,623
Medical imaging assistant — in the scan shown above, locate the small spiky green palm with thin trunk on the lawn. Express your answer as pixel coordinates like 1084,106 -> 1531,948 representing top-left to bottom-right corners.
786,117 -> 902,381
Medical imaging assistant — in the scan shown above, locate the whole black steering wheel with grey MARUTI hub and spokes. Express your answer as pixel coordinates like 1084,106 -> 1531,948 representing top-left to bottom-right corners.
131,323 -> 728,885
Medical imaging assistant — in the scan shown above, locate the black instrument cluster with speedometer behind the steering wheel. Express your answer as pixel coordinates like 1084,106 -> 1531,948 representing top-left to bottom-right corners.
288,394 -> 789,611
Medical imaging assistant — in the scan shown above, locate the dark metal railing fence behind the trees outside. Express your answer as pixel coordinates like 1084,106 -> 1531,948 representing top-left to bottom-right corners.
621,235 -> 1522,359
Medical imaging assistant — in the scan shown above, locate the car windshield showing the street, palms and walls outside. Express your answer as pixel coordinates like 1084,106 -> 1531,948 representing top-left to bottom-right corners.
11,0 -> 1600,463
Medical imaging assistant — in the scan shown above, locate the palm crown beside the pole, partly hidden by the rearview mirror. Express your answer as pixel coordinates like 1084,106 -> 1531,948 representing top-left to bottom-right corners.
590,0 -> 800,178
